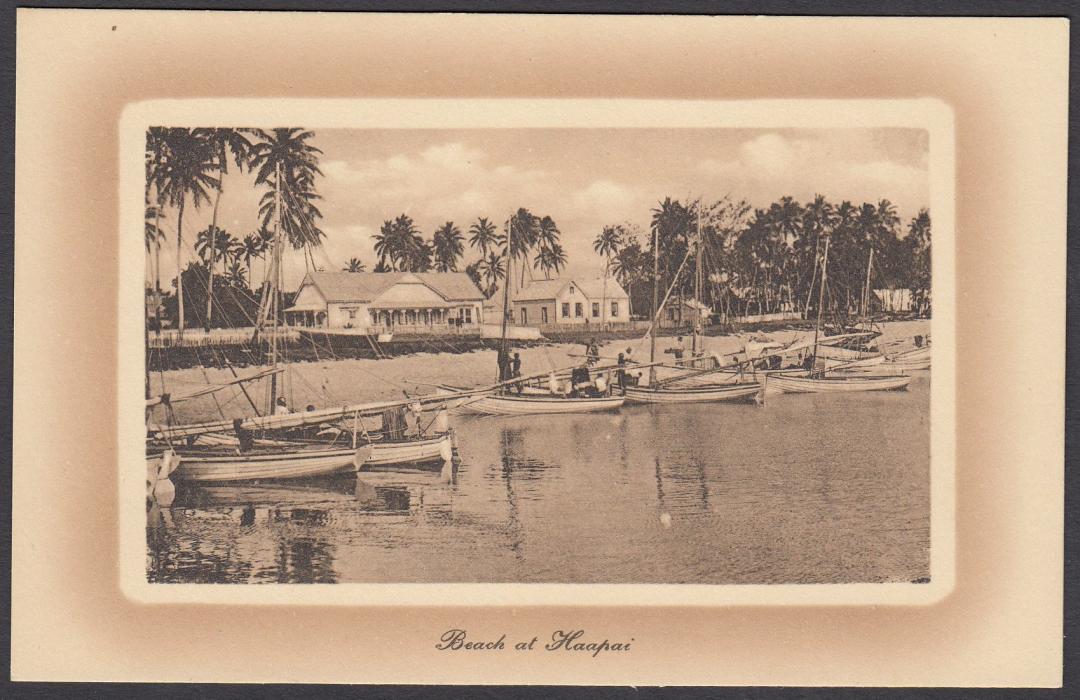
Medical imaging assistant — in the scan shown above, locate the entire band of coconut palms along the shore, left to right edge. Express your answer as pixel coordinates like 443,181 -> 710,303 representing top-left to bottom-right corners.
145,127 -> 931,333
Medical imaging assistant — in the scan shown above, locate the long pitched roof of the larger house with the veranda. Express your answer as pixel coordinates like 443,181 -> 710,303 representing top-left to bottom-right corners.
300,272 -> 484,304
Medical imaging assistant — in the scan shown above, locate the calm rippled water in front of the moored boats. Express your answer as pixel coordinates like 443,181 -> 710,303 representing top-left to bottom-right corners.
147,373 -> 930,583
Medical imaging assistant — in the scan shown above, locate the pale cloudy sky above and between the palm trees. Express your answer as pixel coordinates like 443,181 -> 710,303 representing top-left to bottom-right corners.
152,129 -> 929,286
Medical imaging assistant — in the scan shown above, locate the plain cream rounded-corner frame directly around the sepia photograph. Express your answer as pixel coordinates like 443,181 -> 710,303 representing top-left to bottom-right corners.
117,98 -> 956,607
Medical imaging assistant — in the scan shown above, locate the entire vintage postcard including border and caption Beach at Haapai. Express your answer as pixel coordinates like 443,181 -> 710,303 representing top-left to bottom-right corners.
13,11 -> 1067,685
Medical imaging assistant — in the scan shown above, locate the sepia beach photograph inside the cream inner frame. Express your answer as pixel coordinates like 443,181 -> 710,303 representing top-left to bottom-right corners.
141,112 -> 934,584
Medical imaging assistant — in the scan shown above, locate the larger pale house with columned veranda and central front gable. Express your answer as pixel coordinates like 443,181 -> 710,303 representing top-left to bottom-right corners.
285,272 -> 484,333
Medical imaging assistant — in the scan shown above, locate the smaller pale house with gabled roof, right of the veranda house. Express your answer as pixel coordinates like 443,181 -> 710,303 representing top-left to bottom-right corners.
511,278 -> 630,326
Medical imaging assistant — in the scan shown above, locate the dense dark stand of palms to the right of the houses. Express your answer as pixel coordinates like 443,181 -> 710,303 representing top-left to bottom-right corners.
593,196 -> 930,314
